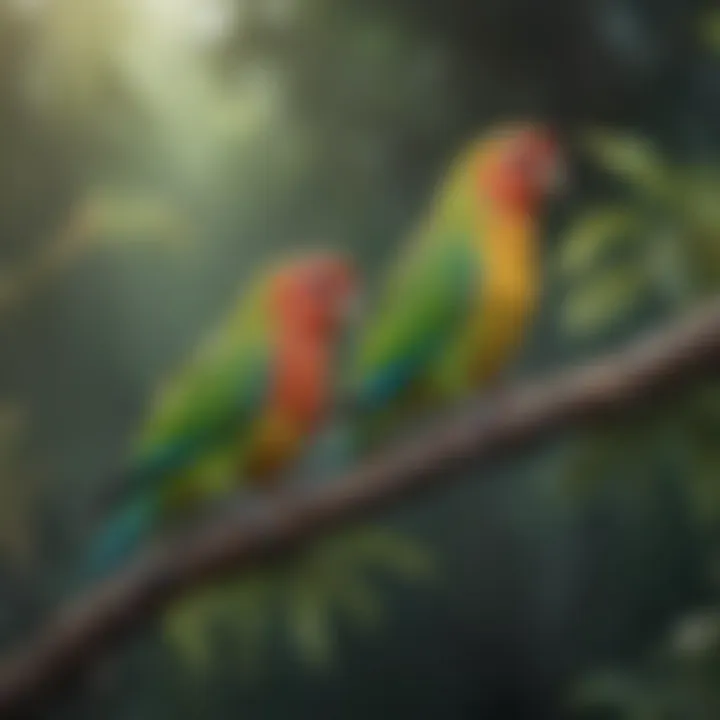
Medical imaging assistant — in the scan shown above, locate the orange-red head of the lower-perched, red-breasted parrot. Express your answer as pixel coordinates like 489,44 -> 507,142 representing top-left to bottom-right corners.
271,252 -> 359,337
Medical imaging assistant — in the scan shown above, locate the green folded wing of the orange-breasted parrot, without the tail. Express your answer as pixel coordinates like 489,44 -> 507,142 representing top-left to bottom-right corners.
126,278 -> 272,504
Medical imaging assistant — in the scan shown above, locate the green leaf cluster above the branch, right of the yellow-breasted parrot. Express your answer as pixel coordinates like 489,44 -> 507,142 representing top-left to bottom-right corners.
560,132 -> 720,336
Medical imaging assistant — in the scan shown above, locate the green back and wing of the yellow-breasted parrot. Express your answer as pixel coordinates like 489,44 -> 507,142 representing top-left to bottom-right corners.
349,139 -> 482,415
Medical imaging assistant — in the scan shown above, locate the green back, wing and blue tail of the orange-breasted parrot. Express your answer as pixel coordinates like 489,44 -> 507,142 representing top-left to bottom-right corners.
87,278 -> 272,576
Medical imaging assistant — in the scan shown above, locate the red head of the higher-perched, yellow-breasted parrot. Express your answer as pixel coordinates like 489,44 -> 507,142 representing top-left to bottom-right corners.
475,124 -> 565,214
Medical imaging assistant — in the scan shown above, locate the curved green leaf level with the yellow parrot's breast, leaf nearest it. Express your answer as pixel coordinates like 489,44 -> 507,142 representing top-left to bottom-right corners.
559,207 -> 645,275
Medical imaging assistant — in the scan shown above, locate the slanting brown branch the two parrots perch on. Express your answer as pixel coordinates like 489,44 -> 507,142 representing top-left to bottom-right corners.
0,300 -> 720,718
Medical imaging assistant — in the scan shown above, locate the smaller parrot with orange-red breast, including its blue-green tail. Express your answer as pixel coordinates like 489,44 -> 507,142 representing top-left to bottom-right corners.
91,252 -> 357,574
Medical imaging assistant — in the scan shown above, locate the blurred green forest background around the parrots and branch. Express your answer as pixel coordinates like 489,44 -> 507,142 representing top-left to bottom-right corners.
0,0 -> 720,720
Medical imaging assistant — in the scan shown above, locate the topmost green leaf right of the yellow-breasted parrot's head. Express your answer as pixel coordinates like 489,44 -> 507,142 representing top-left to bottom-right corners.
585,130 -> 668,196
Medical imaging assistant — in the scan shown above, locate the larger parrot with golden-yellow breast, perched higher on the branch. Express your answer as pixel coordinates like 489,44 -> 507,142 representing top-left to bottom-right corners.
346,124 -> 562,435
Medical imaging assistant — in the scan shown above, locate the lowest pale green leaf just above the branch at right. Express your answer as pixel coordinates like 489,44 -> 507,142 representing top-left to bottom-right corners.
562,265 -> 649,335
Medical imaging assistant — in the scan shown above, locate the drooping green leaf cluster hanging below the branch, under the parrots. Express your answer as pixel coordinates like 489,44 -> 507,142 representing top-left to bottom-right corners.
165,528 -> 433,675
